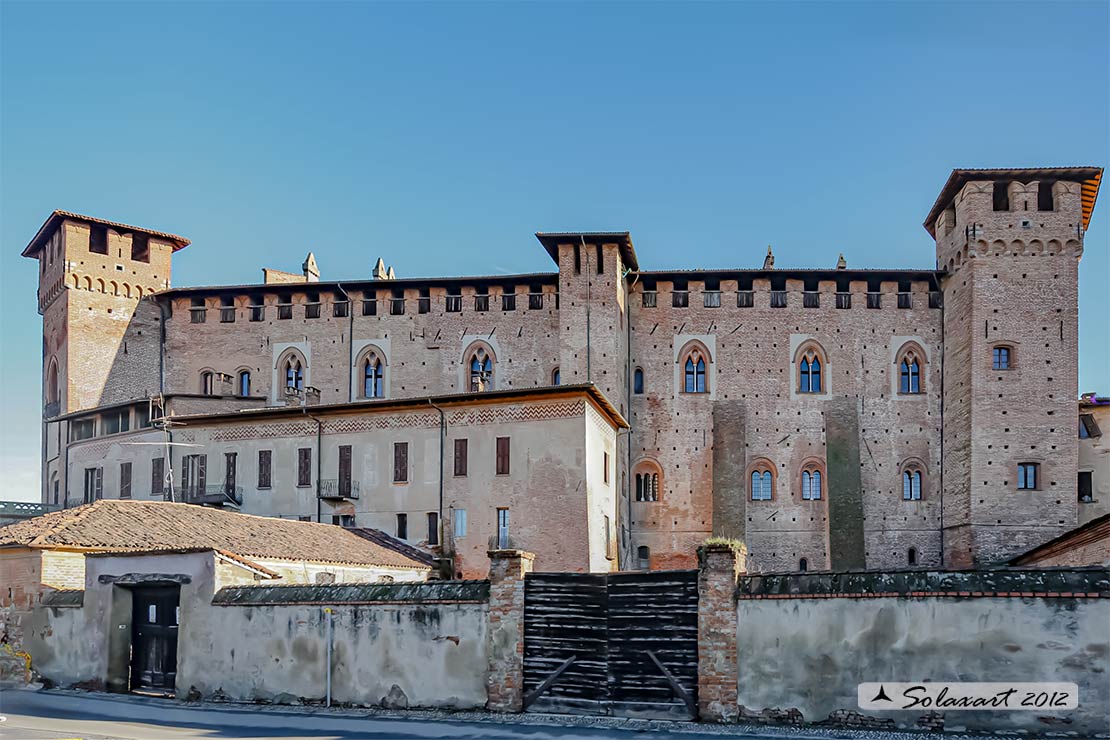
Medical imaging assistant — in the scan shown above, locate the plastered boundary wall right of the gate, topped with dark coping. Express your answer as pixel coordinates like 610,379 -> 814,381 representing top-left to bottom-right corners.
736,568 -> 1110,734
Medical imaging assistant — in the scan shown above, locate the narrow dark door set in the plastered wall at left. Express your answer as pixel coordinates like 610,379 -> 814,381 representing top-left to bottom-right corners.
131,586 -> 181,691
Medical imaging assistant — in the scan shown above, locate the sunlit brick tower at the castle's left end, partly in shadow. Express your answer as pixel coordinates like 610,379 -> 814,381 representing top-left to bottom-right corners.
23,211 -> 189,503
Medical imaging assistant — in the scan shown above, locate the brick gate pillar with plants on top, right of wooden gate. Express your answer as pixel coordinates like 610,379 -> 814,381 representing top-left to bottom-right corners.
697,543 -> 747,722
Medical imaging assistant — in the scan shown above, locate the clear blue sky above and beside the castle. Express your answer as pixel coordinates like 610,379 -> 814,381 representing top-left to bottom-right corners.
0,0 -> 1110,499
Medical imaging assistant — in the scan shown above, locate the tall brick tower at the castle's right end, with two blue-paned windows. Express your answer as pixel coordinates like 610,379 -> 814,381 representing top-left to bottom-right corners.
925,168 -> 1102,567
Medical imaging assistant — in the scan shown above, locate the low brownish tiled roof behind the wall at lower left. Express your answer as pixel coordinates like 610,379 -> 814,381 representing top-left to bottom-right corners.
0,499 -> 427,569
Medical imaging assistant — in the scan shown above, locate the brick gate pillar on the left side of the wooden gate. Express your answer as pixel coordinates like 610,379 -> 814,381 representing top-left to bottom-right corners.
486,550 -> 536,712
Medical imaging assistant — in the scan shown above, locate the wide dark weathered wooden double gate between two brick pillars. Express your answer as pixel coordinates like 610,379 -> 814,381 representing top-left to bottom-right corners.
524,570 -> 697,719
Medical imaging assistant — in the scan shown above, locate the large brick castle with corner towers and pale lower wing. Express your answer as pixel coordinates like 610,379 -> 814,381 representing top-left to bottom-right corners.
23,168 -> 1102,577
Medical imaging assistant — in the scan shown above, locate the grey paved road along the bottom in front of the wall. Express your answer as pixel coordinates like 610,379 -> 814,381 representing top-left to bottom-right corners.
0,691 -> 745,740
